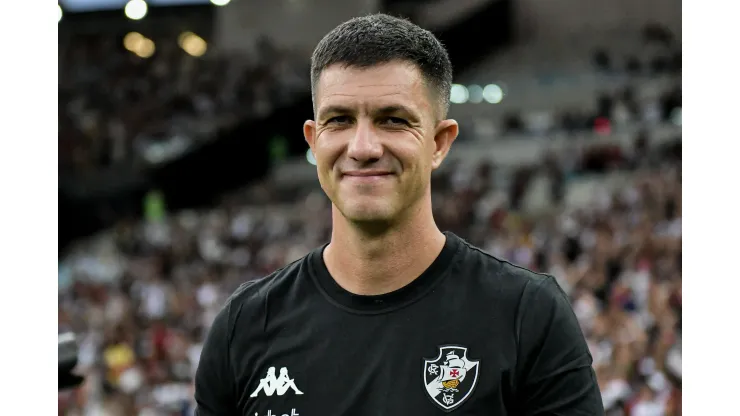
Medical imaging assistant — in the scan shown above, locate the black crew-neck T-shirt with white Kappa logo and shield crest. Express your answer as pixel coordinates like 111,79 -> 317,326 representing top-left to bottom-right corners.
195,233 -> 604,416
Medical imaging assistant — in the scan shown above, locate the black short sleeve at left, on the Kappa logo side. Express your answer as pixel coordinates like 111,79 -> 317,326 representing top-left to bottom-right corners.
195,302 -> 238,416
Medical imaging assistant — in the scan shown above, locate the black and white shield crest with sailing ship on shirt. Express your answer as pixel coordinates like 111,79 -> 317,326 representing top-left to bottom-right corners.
424,345 -> 480,411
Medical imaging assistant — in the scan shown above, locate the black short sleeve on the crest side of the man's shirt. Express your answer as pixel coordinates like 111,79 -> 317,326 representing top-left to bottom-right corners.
515,276 -> 604,416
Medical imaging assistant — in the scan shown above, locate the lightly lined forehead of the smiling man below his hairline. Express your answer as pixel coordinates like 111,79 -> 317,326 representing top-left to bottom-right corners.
316,62 -> 433,114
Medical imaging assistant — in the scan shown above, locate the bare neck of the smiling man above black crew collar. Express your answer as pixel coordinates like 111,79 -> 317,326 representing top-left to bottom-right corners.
324,200 -> 445,295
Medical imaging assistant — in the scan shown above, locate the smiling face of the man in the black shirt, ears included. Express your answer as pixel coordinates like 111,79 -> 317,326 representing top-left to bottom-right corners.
304,62 -> 457,223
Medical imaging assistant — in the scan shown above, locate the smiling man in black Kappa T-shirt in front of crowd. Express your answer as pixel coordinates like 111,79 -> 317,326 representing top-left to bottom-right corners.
195,14 -> 603,416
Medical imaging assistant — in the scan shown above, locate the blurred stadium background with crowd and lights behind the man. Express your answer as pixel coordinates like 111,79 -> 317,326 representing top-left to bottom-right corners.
58,0 -> 681,416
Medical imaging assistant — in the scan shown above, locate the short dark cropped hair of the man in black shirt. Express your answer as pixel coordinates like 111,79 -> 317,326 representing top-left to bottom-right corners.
311,13 -> 452,117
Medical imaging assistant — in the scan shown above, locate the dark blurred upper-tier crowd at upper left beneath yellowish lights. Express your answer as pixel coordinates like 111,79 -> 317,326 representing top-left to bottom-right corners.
59,32 -> 309,174
